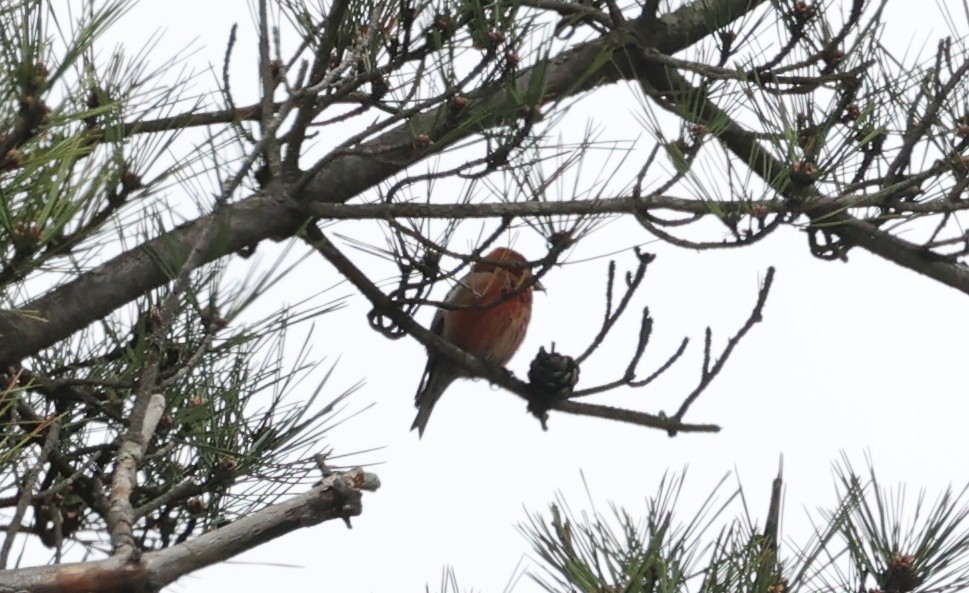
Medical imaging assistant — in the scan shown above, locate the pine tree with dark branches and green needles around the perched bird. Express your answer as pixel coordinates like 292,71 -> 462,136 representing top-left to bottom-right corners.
0,0 -> 969,593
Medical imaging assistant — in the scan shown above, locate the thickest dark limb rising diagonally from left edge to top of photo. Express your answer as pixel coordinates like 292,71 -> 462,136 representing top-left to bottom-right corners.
0,0 -> 763,364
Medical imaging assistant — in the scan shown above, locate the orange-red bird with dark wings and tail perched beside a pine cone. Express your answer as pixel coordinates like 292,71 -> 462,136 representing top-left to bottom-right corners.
411,247 -> 544,438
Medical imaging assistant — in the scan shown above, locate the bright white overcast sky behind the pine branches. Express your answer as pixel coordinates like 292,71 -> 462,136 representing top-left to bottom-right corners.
81,0 -> 969,593
